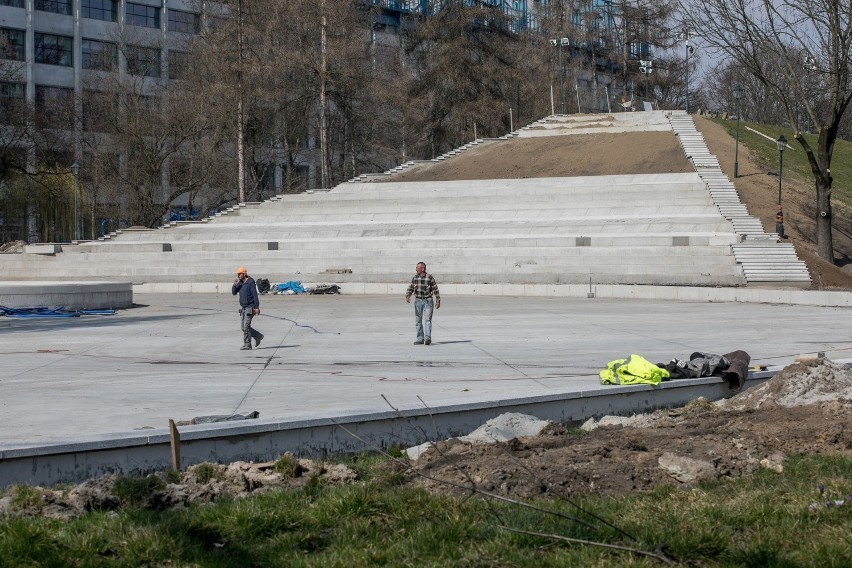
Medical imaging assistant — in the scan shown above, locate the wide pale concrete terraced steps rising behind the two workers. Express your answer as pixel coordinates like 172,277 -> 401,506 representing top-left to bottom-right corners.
0,174 -> 746,290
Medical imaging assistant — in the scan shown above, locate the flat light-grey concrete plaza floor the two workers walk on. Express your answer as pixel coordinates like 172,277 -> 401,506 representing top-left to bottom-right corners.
0,293 -> 852,450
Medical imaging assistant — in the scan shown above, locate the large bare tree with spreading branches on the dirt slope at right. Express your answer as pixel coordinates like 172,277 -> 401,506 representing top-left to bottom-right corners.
681,0 -> 852,263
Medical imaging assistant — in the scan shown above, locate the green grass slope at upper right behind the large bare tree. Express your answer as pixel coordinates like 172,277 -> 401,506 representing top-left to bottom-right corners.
712,119 -> 852,207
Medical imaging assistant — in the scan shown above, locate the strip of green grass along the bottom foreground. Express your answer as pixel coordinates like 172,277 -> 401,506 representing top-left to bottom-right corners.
0,456 -> 852,568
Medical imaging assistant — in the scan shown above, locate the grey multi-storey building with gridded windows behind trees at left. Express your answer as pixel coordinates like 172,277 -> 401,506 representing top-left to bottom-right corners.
0,0 -> 322,240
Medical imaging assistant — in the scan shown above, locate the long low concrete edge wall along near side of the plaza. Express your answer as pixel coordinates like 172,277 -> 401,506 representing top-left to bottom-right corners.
0,372 -> 774,487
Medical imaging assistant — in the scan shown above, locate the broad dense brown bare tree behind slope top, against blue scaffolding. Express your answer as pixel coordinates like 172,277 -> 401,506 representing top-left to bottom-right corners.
403,0 -> 550,157
